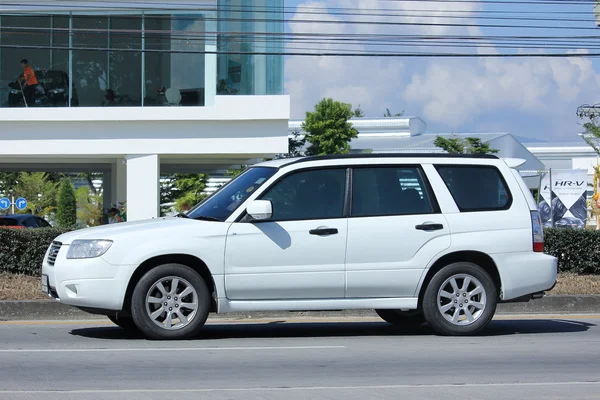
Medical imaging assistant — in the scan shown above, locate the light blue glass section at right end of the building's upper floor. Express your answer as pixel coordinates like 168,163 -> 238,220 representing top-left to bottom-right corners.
217,0 -> 284,95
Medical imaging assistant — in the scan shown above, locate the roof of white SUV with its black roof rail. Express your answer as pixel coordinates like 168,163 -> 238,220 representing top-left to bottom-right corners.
254,153 -> 499,168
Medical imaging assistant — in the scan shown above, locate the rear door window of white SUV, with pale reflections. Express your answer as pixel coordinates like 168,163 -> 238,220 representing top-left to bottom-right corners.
352,167 -> 435,217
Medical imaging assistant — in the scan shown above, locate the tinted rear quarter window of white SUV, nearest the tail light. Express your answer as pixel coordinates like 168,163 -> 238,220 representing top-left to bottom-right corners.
436,165 -> 512,212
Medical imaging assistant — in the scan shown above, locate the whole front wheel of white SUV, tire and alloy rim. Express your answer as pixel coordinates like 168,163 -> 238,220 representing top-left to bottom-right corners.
131,264 -> 210,340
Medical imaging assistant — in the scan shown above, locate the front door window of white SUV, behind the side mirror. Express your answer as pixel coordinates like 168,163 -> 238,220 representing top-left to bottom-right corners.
261,169 -> 346,221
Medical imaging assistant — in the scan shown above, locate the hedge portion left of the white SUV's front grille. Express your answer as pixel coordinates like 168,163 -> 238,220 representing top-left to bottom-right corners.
0,228 -> 70,276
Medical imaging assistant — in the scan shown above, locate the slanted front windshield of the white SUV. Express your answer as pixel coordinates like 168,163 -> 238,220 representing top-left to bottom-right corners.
186,167 -> 277,221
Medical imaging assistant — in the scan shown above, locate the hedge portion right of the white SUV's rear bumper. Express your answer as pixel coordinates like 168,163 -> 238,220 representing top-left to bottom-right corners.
544,228 -> 600,274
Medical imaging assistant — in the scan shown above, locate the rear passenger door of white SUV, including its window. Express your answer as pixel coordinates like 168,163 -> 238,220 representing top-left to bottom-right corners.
346,165 -> 450,298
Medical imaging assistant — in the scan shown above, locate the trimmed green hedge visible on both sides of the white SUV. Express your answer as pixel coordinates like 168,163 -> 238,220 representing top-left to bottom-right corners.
0,228 -> 600,276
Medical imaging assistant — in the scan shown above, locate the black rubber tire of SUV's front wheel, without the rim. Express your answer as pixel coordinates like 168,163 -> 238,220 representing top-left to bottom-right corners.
131,264 -> 211,340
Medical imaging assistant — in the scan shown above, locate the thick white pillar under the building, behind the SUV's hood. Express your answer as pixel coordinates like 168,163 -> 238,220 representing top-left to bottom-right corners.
127,154 -> 160,221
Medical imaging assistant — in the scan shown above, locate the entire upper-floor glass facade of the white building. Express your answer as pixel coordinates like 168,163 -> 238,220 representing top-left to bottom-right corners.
0,0 -> 283,107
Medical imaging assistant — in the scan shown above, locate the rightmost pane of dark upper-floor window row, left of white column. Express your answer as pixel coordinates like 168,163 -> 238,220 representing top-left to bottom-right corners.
144,14 -> 205,106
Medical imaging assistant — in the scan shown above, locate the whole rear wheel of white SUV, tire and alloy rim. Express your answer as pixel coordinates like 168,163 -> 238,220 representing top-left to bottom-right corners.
423,262 -> 498,336
